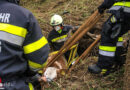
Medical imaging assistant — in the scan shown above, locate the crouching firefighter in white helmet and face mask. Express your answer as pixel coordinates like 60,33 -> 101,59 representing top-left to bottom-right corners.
48,14 -> 78,63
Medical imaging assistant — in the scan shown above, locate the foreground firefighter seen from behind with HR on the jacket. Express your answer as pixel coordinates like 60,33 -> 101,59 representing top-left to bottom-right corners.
0,0 -> 49,90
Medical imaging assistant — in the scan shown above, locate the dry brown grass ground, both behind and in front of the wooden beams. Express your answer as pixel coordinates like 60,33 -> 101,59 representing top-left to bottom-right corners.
22,0 -> 124,90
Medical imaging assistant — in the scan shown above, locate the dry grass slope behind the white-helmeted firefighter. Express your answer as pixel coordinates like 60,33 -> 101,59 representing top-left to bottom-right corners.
23,0 -> 105,36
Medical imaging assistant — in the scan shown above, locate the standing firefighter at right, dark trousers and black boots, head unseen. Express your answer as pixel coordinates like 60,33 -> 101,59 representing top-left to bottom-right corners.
88,0 -> 130,75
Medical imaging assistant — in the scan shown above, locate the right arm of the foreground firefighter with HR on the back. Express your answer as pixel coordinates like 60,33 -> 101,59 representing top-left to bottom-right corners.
23,14 -> 49,72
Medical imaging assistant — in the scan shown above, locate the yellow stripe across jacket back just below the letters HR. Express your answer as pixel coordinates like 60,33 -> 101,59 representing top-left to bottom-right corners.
0,23 -> 27,38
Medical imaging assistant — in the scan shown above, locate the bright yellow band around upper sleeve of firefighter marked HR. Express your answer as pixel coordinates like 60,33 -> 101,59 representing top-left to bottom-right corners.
23,36 -> 48,54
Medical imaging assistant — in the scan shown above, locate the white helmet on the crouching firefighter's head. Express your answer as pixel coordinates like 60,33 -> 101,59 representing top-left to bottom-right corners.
50,14 -> 63,26
